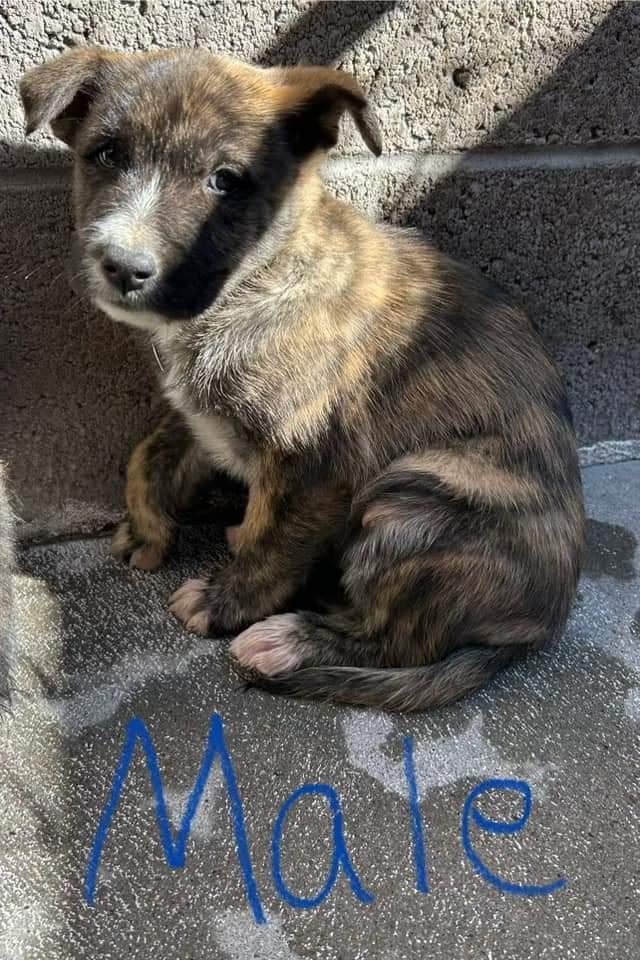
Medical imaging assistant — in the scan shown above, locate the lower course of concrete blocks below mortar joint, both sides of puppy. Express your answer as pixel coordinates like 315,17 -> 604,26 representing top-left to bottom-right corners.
0,160 -> 640,535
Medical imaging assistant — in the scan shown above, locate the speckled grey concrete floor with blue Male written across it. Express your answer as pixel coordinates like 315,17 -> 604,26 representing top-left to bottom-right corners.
0,457 -> 640,960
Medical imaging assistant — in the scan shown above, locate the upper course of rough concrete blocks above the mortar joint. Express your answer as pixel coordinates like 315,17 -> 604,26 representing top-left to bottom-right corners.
0,0 -> 640,166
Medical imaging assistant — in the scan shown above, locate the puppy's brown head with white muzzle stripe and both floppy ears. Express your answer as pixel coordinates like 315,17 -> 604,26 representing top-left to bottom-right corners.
20,48 -> 381,326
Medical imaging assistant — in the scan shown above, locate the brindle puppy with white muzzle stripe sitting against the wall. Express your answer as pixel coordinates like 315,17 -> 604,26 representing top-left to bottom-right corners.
21,48 -> 583,710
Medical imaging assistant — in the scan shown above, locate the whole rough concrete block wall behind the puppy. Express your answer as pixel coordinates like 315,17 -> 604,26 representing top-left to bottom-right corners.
0,0 -> 640,532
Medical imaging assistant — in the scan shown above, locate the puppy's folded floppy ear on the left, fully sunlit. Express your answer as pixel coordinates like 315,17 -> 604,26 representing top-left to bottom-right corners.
20,47 -> 117,146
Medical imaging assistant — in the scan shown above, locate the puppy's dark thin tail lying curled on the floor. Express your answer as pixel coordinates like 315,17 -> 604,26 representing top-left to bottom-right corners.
234,645 -> 523,712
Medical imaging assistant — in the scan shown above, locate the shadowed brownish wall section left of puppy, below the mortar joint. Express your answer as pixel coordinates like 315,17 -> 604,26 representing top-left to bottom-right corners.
0,183 -> 159,532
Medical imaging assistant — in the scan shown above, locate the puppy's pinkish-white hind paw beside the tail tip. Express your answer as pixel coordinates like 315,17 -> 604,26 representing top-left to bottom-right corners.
230,613 -> 304,677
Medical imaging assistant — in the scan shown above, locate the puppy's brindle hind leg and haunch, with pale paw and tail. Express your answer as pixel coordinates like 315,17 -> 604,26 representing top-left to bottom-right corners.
231,452 -> 574,710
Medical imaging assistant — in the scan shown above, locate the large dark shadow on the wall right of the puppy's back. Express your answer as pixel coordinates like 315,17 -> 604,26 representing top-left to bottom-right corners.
388,3 -> 640,442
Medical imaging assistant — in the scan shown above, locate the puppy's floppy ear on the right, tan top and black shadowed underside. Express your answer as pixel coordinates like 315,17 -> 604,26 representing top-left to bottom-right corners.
274,67 -> 382,157
